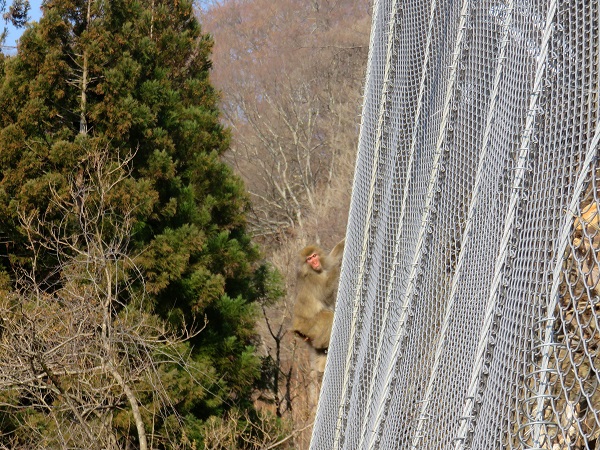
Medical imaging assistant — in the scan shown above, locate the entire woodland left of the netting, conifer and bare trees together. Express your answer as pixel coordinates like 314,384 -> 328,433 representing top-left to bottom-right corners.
0,0 -> 371,449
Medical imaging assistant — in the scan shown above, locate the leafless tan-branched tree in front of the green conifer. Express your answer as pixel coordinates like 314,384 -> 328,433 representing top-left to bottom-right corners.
0,146 -> 202,450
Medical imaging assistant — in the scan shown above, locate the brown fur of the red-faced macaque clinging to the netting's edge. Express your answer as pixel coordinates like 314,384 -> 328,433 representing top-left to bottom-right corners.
292,239 -> 344,350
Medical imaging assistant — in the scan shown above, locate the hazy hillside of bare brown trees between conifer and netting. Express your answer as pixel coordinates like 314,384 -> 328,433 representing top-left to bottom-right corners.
203,0 -> 370,243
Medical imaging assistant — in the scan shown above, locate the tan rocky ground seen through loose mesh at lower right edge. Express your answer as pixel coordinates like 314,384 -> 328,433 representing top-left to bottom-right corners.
544,201 -> 600,449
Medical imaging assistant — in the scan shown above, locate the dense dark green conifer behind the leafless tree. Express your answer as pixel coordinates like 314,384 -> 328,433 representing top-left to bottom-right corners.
0,0 -> 278,442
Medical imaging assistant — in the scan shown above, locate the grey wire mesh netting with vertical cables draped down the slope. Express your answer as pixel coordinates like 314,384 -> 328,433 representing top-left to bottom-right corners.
312,0 -> 600,450
